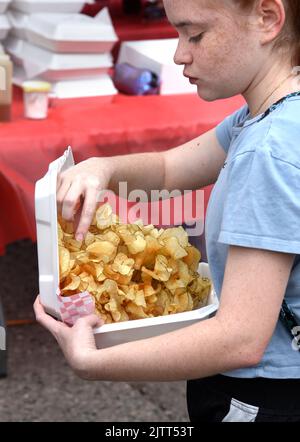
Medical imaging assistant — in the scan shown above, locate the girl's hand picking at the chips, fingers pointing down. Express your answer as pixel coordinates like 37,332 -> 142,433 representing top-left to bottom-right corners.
57,158 -> 111,241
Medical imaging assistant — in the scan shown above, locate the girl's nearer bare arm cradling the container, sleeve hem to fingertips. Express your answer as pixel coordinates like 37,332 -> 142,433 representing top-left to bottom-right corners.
35,246 -> 294,381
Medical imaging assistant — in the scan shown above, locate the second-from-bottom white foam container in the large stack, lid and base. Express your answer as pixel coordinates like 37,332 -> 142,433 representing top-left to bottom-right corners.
4,37 -> 113,81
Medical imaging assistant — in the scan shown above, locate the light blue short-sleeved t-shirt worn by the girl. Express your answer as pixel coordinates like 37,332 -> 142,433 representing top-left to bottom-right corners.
206,96 -> 300,379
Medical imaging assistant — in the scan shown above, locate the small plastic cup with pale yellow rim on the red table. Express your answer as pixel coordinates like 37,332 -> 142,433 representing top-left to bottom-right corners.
22,81 -> 51,120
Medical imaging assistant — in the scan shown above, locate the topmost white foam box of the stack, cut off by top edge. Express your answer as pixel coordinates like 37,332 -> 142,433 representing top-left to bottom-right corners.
12,0 -> 94,14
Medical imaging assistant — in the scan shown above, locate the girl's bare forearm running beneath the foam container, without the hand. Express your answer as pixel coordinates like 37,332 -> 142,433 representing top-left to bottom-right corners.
81,317 -> 257,381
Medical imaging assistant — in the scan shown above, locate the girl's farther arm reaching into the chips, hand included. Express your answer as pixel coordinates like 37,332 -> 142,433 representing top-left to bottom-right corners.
57,129 -> 226,240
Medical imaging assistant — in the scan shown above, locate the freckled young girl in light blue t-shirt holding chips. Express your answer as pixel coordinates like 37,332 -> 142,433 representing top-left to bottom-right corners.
35,0 -> 300,422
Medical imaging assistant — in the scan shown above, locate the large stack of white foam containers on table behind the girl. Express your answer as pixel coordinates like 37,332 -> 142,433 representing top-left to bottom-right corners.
4,0 -> 118,98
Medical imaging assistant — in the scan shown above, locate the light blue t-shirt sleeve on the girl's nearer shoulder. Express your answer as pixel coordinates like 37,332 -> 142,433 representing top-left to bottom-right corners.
218,146 -> 300,254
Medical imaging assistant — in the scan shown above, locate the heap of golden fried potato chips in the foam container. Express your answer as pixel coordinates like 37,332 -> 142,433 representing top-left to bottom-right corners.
58,204 -> 211,324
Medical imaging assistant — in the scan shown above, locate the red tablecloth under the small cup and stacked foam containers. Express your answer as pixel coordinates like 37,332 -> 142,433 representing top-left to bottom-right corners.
0,89 -> 243,253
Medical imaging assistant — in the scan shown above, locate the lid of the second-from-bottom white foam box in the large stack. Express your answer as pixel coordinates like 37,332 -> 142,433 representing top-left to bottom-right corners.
5,37 -> 113,77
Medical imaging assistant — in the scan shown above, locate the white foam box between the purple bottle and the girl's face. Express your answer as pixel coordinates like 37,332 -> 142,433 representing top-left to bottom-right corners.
118,38 -> 197,94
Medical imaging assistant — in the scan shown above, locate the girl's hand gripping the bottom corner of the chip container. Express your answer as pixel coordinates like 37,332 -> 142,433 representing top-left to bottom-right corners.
34,296 -> 103,379
